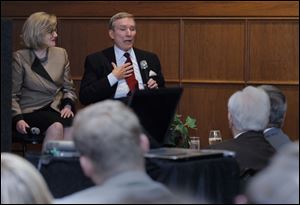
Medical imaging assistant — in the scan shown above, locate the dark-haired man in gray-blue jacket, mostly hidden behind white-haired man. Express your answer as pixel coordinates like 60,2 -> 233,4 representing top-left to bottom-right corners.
259,85 -> 291,151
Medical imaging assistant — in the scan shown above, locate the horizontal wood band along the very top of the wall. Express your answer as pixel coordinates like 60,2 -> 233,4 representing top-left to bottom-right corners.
1,1 -> 299,17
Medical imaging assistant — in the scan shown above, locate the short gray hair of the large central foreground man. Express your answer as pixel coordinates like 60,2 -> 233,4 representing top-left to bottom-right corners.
73,100 -> 144,176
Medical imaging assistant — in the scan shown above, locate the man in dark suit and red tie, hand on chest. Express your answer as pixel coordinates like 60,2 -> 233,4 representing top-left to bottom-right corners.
79,12 -> 164,105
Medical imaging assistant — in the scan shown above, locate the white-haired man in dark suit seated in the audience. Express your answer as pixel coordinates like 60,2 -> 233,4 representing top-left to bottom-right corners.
210,86 -> 275,175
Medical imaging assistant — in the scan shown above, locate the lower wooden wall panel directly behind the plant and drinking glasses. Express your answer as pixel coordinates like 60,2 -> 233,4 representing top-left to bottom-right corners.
180,84 -> 243,148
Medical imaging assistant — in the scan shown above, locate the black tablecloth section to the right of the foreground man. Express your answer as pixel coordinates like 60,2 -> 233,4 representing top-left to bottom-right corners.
146,157 -> 239,203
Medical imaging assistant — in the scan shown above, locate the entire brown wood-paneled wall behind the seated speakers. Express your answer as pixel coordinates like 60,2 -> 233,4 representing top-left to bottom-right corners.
1,1 -> 299,147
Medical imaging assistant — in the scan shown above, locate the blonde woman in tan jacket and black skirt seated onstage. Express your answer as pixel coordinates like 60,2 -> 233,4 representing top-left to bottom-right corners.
12,12 -> 77,147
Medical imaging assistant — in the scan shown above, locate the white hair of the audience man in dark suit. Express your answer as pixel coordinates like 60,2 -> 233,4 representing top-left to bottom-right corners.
228,86 -> 270,131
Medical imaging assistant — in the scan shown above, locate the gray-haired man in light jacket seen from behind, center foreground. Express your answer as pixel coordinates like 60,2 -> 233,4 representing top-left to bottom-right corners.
57,100 -> 173,203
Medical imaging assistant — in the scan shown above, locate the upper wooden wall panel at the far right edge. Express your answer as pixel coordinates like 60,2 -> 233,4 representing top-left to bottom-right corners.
249,20 -> 299,83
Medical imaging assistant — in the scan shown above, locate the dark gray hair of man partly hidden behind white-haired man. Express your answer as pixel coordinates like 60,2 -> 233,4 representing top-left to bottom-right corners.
258,85 -> 287,128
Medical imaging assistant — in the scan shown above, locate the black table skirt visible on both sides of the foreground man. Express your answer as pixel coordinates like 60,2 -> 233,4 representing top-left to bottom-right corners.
27,151 -> 239,203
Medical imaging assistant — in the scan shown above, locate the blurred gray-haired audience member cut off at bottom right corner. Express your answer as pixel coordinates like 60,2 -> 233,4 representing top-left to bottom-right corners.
246,141 -> 299,204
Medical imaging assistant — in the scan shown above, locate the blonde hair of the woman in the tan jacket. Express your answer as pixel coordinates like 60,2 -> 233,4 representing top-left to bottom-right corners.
21,12 -> 57,49
